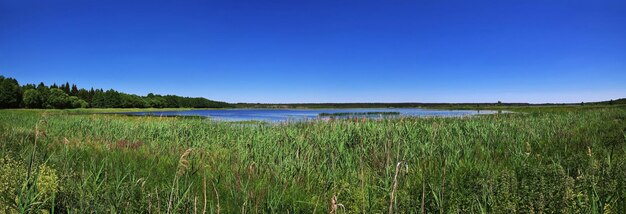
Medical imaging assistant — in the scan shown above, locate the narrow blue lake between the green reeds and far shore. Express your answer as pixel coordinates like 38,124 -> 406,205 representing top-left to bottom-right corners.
122,108 -> 497,122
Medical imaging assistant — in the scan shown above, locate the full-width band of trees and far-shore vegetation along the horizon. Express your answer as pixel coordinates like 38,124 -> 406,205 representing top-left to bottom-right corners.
0,75 -> 626,112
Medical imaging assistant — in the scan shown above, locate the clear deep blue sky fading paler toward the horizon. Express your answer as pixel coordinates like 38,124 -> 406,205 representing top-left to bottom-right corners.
0,0 -> 626,102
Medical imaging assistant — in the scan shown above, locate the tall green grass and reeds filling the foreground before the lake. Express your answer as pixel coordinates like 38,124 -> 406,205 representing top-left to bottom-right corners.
0,106 -> 626,213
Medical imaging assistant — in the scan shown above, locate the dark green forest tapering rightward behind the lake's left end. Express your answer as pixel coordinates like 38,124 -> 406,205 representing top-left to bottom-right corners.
0,75 -> 232,109
